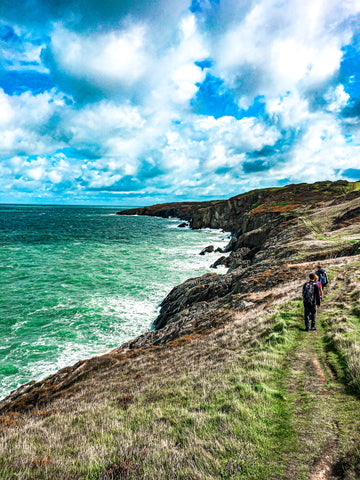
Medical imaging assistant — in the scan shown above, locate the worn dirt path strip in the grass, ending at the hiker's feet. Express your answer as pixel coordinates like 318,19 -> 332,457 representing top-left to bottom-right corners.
288,332 -> 343,480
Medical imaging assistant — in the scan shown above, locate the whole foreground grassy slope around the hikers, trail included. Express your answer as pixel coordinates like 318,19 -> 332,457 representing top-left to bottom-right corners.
0,262 -> 360,480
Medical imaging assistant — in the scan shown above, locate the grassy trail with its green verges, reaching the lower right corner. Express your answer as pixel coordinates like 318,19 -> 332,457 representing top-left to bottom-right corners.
272,275 -> 360,480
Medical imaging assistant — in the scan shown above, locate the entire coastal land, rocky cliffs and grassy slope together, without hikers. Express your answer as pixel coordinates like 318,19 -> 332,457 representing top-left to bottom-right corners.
0,181 -> 360,480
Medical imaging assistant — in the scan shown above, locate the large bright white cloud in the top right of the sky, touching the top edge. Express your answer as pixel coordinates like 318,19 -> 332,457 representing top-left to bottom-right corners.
212,0 -> 354,96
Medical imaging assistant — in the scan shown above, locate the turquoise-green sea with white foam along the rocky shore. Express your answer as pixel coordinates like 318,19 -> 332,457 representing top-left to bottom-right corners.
0,205 -> 229,399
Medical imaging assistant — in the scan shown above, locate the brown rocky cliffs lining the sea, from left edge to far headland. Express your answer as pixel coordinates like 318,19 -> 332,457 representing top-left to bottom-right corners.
0,181 -> 360,415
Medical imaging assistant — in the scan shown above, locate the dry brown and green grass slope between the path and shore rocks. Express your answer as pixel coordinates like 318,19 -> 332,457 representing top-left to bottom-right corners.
0,280 -> 300,480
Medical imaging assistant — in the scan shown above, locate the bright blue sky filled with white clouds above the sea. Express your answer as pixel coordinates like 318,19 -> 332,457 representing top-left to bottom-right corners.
0,0 -> 360,206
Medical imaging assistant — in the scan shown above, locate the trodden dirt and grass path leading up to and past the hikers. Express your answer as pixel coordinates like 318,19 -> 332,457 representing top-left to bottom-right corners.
286,274 -> 358,480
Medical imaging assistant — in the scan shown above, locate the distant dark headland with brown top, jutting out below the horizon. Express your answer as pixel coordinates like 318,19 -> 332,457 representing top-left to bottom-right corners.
118,180 -> 359,236
